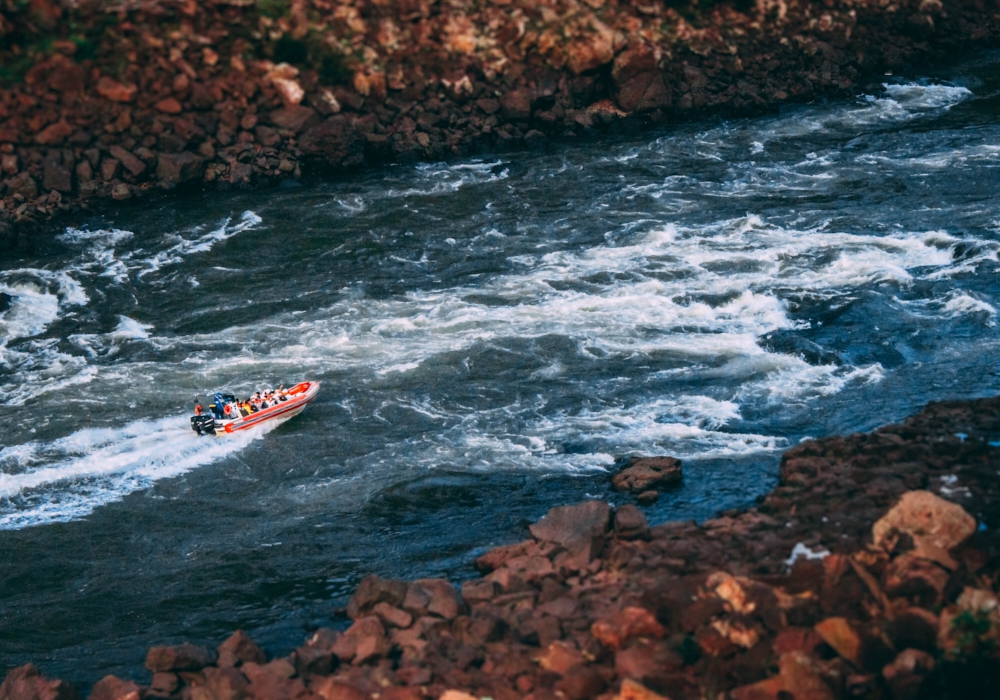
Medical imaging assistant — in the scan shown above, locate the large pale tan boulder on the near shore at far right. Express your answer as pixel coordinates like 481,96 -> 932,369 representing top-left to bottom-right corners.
872,491 -> 976,551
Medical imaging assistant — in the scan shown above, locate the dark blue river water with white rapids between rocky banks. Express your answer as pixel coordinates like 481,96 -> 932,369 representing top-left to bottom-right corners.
0,59 -> 1000,682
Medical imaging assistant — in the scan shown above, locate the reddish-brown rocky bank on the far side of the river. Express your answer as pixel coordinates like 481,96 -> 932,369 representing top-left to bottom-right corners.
0,0 -> 1000,246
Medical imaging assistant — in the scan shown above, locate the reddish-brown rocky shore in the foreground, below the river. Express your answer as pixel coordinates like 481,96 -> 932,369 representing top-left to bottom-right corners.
0,398 -> 1000,700
